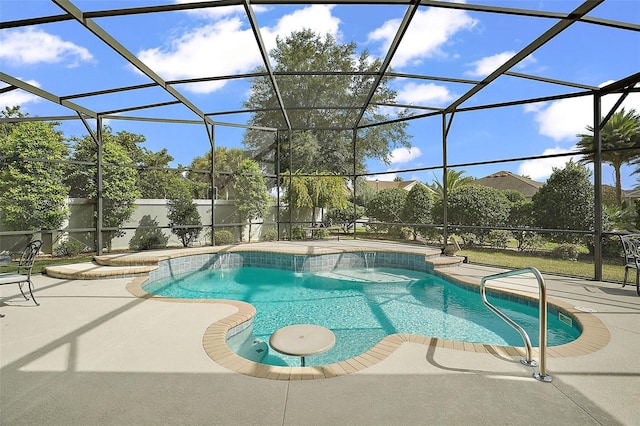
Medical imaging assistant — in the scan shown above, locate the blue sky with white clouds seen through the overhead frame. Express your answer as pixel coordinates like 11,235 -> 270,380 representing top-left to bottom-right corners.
0,0 -> 640,189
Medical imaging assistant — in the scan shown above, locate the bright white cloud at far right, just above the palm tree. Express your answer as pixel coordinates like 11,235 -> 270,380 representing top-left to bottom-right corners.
525,83 -> 640,143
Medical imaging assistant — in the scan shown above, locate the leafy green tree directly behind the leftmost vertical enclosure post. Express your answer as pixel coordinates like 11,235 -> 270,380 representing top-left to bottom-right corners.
66,132 -> 141,250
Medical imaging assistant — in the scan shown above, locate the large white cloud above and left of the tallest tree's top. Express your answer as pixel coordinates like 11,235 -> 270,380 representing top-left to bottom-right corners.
137,5 -> 340,93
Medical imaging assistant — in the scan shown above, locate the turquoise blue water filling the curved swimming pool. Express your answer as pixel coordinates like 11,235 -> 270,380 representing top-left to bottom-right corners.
144,267 -> 580,365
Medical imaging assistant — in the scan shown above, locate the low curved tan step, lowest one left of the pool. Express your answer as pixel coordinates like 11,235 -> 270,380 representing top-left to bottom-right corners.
44,262 -> 158,280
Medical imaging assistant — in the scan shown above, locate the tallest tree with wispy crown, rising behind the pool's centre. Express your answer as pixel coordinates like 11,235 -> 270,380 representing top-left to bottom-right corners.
243,30 -> 409,175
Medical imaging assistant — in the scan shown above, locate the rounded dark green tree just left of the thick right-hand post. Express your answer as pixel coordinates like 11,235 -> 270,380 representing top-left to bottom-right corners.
533,161 -> 594,248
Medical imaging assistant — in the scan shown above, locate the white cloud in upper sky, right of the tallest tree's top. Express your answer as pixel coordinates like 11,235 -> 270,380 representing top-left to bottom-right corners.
369,8 -> 477,67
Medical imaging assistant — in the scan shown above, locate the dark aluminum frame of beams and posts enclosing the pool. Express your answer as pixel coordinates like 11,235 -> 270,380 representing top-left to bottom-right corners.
0,0 -> 640,279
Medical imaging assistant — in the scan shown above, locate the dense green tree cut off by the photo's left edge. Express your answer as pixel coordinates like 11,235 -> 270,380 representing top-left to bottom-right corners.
0,121 -> 69,231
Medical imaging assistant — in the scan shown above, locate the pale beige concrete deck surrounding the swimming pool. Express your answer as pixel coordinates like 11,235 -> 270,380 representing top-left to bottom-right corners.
0,240 -> 640,425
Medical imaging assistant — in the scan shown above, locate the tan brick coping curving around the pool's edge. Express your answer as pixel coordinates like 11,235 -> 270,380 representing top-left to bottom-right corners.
126,249 -> 611,380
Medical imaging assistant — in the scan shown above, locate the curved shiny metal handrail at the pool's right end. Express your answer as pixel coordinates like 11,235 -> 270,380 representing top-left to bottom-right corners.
480,266 -> 551,383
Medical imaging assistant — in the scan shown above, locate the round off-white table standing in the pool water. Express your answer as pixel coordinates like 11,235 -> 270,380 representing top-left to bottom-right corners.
269,324 -> 336,367
